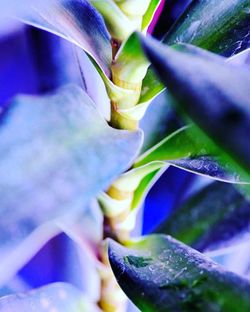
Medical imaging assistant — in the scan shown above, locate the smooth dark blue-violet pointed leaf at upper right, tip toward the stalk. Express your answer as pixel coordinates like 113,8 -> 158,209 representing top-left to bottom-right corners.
142,38 -> 250,172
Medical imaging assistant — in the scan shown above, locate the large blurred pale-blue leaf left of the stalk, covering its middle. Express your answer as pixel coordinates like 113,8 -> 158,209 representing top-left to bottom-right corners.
0,86 -> 142,283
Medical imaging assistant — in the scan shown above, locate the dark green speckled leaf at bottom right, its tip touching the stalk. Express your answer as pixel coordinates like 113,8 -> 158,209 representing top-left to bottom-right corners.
109,235 -> 250,312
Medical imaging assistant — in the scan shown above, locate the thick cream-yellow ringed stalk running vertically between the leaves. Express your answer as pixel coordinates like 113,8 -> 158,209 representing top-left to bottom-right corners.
93,0 -> 150,312
